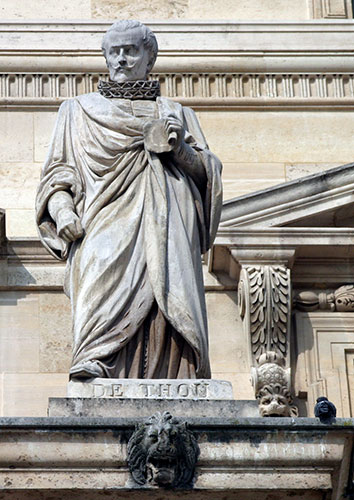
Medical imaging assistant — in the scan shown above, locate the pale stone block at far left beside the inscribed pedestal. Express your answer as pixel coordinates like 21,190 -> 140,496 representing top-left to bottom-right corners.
3,373 -> 68,417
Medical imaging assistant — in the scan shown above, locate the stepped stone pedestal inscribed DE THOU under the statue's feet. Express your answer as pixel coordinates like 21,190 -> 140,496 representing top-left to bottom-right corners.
48,378 -> 259,419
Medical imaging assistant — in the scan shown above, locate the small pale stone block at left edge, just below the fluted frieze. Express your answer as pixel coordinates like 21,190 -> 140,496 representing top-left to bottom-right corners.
0,111 -> 34,163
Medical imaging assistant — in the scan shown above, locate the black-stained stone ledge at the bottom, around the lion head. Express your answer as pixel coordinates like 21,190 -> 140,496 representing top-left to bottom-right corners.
0,417 -> 353,500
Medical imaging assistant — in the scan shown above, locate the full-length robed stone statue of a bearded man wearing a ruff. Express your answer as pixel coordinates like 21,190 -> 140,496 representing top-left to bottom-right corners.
36,21 -> 222,380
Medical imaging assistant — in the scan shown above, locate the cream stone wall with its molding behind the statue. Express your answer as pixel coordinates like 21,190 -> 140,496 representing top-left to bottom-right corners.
0,16 -> 354,416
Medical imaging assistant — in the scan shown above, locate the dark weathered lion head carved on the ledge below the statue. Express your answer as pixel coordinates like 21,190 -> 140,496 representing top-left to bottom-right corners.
128,412 -> 199,487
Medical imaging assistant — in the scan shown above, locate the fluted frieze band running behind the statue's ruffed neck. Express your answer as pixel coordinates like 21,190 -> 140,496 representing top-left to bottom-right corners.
0,73 -> 354,107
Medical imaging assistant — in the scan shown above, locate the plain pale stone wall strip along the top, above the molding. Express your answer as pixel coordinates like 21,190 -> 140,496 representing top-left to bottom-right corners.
0,0 -> 332,20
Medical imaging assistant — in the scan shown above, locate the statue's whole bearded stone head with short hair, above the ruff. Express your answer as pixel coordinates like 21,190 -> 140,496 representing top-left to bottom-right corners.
102,20 -> 158,83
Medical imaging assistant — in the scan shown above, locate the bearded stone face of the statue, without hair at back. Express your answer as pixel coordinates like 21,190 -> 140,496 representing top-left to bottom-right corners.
105,28 -> 150,83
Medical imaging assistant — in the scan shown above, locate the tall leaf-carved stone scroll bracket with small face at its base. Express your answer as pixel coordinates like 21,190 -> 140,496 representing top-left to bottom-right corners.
231,249 -> 298,417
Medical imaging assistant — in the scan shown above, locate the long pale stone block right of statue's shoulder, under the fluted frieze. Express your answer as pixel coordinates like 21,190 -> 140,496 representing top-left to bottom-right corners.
197,110 -> 354,165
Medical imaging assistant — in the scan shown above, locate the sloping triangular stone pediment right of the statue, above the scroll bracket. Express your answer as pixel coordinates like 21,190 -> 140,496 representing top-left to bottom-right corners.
220,163 -> 354,229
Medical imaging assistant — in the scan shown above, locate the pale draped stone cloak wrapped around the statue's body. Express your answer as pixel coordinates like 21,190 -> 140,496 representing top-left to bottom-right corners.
36,93 -> 222,378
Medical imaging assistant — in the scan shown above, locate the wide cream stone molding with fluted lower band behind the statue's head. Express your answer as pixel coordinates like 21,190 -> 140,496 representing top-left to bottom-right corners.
0,20 -> 354,110
